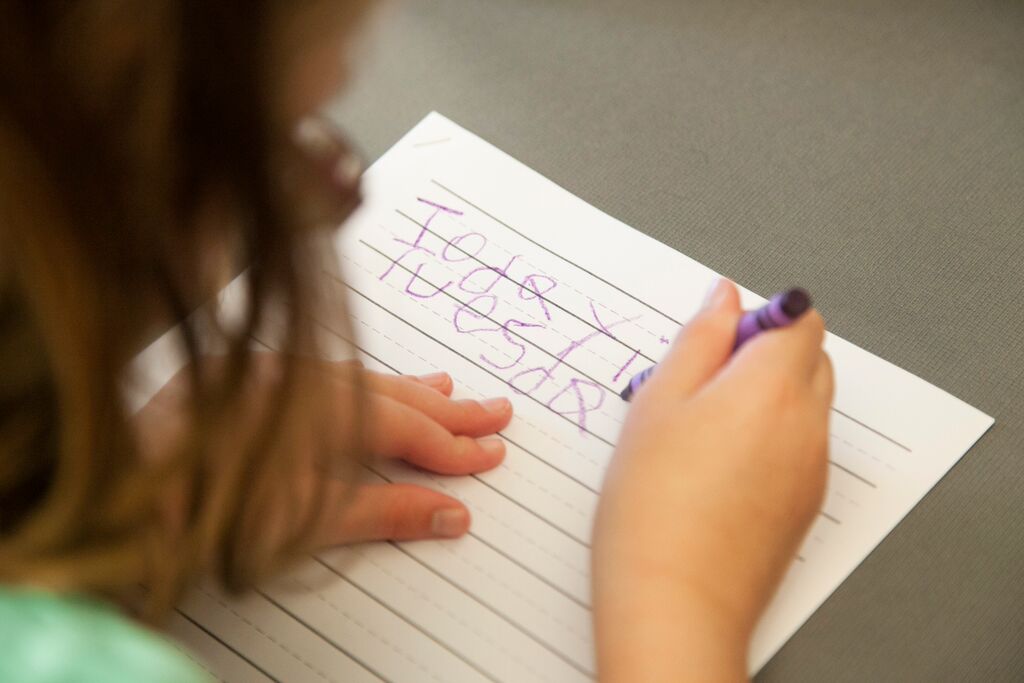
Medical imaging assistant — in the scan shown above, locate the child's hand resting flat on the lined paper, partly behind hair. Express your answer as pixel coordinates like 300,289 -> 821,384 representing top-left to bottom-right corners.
135,353 -> 512,549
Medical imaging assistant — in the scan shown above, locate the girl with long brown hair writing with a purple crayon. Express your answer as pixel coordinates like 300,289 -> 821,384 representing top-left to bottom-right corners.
0,0 -> 831,681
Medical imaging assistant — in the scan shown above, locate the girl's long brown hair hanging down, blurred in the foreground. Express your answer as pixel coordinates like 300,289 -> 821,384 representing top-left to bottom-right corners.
0,0 -> 368,615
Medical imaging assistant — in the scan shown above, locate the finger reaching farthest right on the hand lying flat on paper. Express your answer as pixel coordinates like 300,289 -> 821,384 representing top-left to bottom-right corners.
367,373 -> 512,436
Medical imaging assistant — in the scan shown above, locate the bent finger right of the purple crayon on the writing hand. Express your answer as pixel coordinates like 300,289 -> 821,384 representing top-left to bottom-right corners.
736,308 -> 825,379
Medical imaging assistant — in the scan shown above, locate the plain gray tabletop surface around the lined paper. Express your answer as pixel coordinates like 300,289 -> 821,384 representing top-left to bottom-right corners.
336,0 -> 1024,681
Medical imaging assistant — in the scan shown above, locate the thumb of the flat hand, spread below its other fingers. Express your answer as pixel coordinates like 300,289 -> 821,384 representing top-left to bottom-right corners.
325,483 -> 470,545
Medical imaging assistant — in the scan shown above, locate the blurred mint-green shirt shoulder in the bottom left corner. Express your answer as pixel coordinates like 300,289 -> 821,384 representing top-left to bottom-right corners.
0,587 -> 210,683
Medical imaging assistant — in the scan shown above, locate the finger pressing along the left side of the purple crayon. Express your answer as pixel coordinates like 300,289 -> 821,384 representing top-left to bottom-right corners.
647,279 -> 742,396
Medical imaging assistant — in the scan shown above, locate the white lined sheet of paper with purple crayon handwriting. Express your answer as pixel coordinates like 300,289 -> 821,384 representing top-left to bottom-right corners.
136,114 -> 992,683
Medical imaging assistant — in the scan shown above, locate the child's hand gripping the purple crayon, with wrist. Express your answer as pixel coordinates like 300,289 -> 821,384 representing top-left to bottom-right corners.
593,282 -> 833,681
